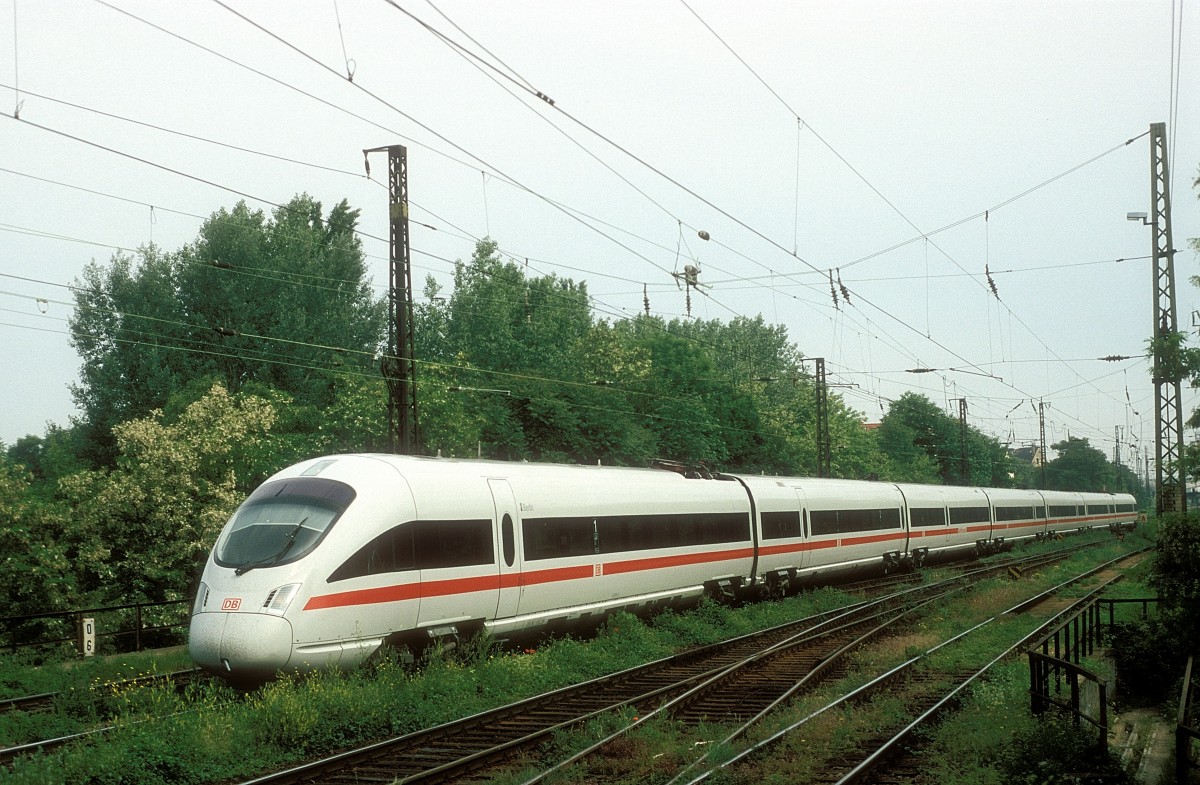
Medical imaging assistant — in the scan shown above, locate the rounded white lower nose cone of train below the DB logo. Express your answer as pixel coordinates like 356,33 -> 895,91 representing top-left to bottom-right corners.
188,612 -> 292,683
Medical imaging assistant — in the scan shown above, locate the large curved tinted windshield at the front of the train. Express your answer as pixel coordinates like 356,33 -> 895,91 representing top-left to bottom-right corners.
214,477 -> 354,575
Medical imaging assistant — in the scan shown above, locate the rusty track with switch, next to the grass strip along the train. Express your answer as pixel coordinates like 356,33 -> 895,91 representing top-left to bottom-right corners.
226,544 -> 1113,785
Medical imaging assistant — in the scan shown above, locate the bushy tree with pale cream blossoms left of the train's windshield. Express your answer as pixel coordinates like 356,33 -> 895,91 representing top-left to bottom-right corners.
56,385 -> 276,603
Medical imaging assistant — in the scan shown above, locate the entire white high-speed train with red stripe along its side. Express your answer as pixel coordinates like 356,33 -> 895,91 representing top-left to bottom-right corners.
190,455 -> 1136,682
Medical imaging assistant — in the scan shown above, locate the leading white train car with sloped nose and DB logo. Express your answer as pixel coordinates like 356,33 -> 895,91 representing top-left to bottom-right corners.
190,455 -> 755,682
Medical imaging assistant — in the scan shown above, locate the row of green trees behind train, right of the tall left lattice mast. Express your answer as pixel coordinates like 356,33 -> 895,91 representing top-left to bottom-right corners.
415,240 -> 897,477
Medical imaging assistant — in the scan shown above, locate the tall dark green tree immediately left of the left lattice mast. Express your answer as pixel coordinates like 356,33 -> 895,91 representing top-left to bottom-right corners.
71,196 -> 386,466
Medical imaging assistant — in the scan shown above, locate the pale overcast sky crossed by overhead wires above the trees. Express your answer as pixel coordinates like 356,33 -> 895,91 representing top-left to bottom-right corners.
0,0 -> 1200,472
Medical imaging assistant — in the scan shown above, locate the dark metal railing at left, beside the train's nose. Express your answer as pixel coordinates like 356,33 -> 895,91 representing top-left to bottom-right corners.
0,600 -> 191,654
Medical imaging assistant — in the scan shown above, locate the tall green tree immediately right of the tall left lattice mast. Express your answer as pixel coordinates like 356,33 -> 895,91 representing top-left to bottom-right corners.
415,239 -> 644,462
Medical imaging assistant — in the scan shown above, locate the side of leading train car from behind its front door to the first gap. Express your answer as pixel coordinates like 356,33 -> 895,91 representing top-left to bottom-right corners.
491,466 -> 754,635
